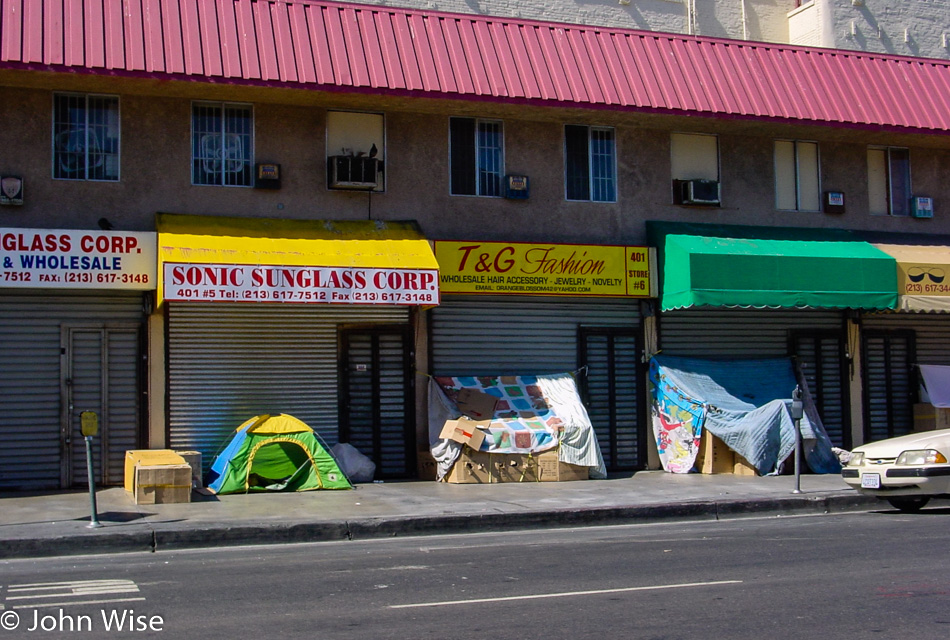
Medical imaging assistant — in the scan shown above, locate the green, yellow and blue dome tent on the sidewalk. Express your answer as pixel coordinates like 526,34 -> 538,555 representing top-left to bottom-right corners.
207,413 -> 353,494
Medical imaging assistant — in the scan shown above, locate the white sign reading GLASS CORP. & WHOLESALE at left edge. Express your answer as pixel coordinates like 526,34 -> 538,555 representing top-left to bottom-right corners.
0,228 -> 157,290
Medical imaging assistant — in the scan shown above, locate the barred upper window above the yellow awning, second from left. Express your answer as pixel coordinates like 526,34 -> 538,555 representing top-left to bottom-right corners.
191,102 -> 254,187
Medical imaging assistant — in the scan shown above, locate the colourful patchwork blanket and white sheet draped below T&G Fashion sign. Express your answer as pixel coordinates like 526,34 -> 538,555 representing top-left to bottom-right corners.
429,373 -> 607,480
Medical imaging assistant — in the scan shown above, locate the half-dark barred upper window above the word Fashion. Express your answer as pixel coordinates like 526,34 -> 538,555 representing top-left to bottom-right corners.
564,124 -> 617,202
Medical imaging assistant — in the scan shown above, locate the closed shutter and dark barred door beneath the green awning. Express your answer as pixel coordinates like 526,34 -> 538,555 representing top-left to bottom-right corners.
659,309 -> 851,448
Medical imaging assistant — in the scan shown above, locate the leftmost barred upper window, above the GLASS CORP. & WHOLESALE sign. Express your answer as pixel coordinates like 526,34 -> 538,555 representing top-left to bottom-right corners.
53,93 -> 119,181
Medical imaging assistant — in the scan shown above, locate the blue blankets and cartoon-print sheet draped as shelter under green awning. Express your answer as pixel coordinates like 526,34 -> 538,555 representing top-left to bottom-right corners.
650,355 -> 841,475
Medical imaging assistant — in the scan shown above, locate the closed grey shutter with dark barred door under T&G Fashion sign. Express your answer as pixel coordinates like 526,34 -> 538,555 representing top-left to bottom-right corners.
430,295 -> 646,470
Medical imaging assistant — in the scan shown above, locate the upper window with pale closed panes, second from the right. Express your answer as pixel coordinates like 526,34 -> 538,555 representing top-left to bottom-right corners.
775,140 -> 821,211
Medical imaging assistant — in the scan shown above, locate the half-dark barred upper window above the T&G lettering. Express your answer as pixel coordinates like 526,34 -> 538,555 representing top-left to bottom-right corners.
449,118 -> 505,196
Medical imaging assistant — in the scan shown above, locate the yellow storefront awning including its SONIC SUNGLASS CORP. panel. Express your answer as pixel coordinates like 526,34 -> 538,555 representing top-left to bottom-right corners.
156,213 -> 439,306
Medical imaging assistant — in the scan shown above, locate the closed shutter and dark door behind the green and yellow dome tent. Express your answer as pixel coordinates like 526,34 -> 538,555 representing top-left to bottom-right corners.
167,302 -> 415,478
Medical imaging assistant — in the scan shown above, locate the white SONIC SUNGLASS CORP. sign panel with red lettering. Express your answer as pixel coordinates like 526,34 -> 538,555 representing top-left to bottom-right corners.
162,262 -> 439,305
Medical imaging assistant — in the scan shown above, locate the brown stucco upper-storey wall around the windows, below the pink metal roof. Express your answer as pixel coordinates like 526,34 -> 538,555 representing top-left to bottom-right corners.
0,87 -> 950,244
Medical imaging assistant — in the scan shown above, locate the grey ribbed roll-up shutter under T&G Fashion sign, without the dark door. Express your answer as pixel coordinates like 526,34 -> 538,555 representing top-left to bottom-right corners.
430,296 -> 640,376
